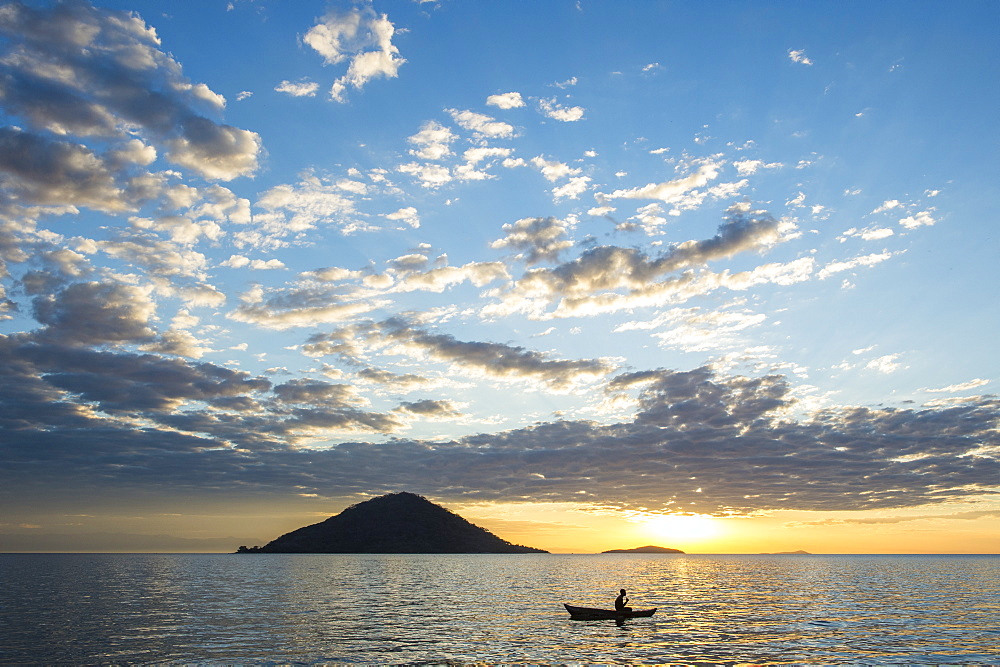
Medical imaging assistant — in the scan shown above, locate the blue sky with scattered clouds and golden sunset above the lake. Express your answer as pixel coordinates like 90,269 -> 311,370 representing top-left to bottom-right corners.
0,0 -> 1000,553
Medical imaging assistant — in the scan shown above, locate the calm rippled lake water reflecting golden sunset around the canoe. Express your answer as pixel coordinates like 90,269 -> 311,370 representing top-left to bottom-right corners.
0,554 -> 1000,664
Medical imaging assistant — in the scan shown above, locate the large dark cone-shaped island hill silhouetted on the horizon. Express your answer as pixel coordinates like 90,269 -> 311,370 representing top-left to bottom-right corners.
237,492 -> 548,554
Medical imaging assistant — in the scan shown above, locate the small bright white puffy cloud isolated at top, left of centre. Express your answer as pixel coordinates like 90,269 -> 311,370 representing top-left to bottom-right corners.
302,7 -> 406,102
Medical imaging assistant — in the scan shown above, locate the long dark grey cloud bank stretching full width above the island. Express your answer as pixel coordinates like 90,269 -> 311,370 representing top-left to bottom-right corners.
0,338 -> 1000,513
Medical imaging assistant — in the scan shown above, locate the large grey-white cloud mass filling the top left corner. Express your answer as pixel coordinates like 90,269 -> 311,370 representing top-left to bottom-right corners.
0,2 -> 261,180
